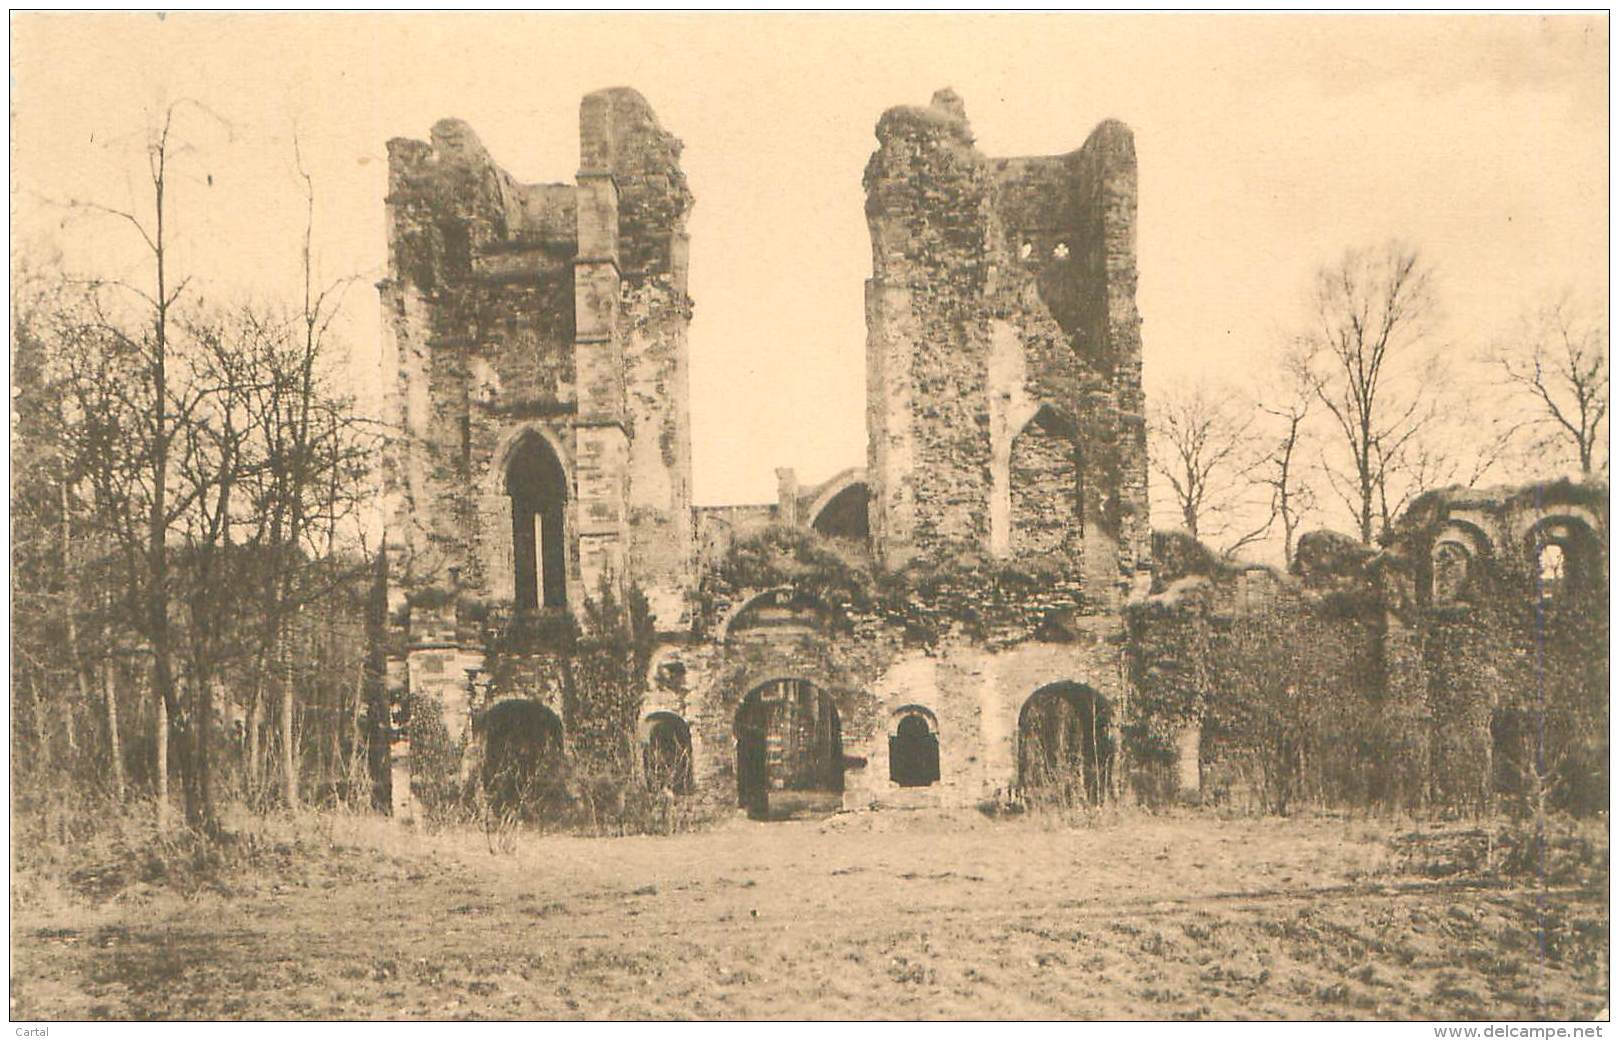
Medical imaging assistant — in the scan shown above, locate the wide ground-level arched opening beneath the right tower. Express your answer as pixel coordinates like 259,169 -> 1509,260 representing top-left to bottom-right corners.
1017,683 -> 1114,805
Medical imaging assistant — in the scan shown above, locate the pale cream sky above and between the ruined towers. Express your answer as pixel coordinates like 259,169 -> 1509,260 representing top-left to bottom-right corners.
11,13 -> 1608,504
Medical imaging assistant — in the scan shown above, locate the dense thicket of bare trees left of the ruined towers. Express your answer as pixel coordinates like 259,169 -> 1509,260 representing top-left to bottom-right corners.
22,104 -> 374,832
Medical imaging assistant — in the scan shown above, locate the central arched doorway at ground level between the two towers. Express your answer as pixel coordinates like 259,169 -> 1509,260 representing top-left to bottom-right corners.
737,680 -> 843,818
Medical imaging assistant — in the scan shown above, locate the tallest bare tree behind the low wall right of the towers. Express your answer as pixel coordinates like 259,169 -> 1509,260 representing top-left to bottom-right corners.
1295,243 -> 1439,542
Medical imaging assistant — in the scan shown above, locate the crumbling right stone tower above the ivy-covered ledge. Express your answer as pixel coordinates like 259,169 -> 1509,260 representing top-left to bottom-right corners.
866,91 -> 1149,614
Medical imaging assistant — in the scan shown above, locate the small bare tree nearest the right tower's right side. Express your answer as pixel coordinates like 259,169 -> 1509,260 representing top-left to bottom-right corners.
1148,382 -> 1264,554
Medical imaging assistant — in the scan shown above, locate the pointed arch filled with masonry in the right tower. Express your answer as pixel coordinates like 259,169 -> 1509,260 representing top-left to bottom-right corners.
1009,405 -> 1085,557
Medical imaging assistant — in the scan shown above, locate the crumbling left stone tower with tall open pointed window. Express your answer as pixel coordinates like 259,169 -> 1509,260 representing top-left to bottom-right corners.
379,87 -> 693,815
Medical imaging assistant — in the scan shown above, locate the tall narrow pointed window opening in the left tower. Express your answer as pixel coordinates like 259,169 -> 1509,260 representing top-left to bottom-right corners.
507,432 -> 568,610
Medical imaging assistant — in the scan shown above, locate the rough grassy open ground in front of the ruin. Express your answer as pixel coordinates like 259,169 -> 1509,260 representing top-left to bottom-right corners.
11,811 -> 1608,1020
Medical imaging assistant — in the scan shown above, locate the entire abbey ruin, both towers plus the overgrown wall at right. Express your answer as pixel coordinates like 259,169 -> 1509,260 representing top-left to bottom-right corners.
380,89 -> 1608,818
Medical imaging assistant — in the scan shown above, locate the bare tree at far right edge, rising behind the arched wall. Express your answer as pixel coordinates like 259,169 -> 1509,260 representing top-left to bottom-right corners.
1486,295 -> 1609,478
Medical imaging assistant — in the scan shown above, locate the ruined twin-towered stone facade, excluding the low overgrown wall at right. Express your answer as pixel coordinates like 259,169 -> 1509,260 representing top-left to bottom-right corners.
379,89 -> 1151,814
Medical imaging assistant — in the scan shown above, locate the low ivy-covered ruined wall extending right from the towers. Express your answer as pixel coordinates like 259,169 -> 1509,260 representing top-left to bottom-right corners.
1127,482 -> 1608,813
